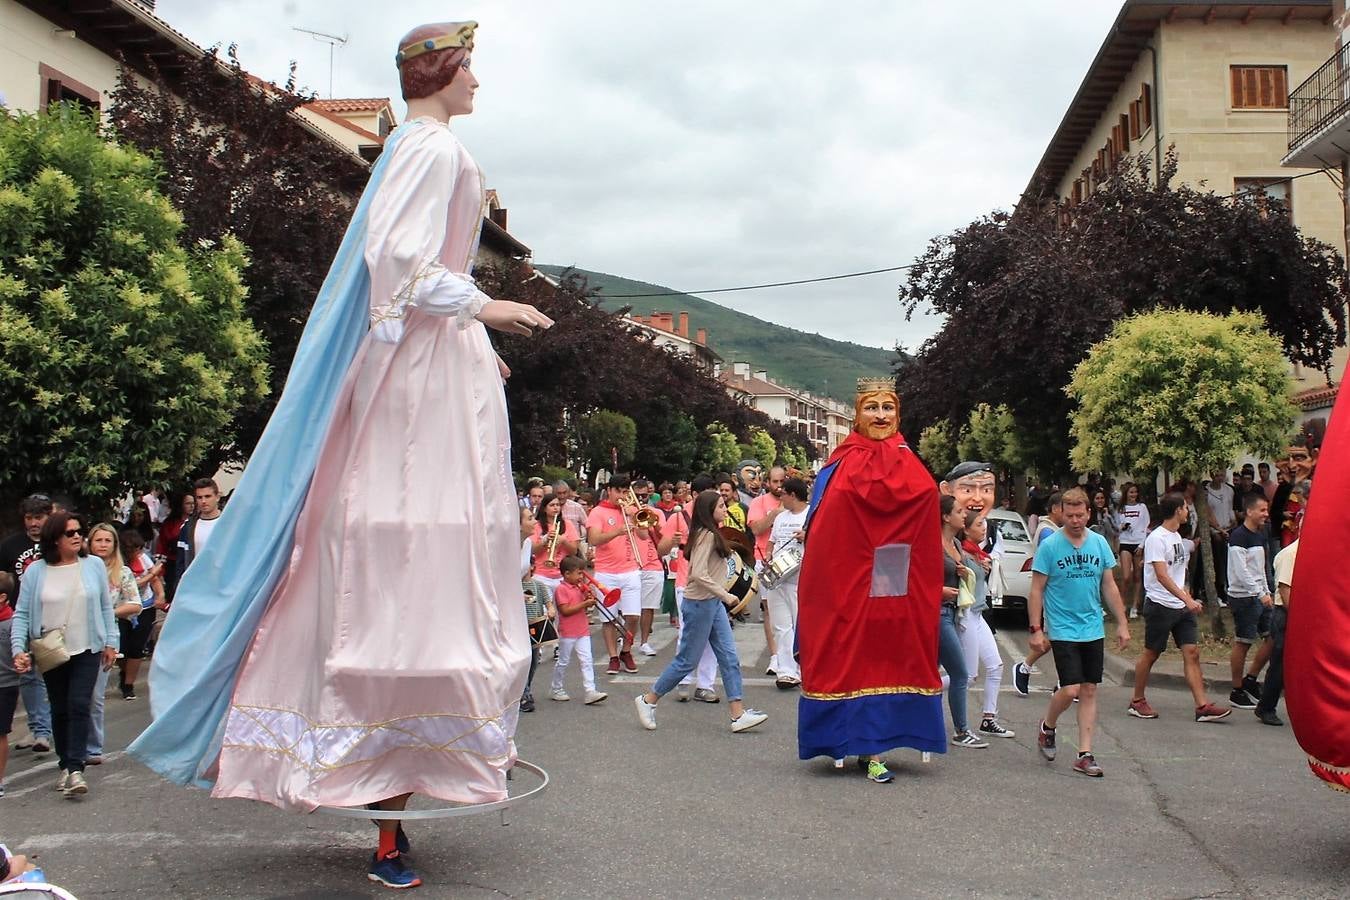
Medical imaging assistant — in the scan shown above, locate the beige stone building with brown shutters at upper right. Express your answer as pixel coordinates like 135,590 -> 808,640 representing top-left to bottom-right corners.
1027,0 -> 1350,412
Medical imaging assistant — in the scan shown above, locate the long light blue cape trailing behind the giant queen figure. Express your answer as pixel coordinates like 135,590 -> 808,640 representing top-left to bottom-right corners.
128,124 -> 410,788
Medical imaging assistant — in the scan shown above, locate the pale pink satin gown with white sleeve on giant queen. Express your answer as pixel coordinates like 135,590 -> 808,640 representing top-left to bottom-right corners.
212,120 -> 529,811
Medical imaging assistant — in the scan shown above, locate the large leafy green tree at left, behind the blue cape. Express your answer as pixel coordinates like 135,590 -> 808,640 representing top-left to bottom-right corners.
0,108 -> 269,510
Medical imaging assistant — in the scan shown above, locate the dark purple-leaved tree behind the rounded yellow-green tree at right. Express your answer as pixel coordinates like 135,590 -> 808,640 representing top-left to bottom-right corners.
896,151 -> 1350,475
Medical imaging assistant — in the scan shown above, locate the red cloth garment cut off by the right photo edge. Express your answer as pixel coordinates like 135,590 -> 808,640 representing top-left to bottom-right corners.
1284,396 -> 1350,791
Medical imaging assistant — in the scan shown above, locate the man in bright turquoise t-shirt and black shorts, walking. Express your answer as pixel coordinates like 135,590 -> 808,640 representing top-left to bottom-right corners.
1027,487 -> 1130,779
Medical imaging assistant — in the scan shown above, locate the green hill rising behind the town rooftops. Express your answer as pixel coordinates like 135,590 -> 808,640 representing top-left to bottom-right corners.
535,264 -> 895,403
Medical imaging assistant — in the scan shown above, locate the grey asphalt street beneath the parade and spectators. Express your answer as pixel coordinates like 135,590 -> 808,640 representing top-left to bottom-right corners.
0,625 -> 1350,899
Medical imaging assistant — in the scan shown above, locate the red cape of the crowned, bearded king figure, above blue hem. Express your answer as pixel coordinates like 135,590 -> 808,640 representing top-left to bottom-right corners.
797,432 -> 942,701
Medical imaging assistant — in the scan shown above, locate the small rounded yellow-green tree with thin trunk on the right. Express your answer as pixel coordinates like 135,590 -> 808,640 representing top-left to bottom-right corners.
1065,310 -> 1297,631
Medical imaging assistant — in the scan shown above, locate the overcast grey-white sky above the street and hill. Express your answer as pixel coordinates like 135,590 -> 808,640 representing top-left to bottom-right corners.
157,0 -> 1121,347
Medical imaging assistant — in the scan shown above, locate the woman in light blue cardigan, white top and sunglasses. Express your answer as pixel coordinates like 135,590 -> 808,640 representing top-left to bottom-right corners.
9,513 -> 119,797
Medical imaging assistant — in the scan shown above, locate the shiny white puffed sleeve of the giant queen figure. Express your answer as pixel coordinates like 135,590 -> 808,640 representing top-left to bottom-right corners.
366,125 -> 490,343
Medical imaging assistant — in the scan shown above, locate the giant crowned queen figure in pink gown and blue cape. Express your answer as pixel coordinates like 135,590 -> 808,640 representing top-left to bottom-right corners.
132,23 -> 552,887
